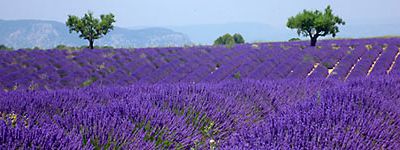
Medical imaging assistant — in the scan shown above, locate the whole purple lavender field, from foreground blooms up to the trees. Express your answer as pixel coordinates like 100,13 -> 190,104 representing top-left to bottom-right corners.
0,38 -> 400,149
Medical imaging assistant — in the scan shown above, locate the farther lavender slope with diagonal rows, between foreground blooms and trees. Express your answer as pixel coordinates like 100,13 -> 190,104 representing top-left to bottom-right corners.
0,39 -> 400,91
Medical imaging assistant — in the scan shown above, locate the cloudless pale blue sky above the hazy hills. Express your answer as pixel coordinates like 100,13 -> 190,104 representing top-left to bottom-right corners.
0,0 -> 400,27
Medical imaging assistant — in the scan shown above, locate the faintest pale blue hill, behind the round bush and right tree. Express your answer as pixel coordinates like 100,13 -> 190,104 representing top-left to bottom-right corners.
164,23 -> 400,44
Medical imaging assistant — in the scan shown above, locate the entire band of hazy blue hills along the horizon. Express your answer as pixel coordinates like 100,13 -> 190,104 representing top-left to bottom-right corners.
0,20 -> 400,48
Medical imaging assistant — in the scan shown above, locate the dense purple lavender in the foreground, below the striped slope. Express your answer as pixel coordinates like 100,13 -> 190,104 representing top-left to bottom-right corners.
0,76 -> 400,149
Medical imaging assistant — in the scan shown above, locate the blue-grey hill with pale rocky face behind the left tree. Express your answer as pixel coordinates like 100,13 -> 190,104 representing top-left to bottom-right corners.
0,20 -> 191,48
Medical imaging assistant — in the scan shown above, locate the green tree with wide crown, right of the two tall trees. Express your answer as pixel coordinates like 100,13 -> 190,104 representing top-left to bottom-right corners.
286,6 -> 345,46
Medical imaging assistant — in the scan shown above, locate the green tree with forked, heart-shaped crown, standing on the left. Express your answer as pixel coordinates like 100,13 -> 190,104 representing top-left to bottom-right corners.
66,12 -> 115,49
